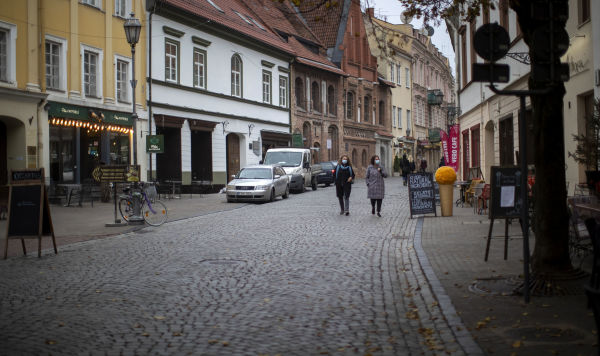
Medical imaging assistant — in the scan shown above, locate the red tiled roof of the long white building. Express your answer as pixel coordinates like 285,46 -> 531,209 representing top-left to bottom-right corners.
163,0 -> 292,54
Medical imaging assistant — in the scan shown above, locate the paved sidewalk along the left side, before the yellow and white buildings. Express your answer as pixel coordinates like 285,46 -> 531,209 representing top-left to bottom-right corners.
0,194 -> 245,258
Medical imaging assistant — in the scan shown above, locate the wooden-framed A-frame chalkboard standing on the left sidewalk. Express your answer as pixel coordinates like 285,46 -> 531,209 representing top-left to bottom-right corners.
4,168 -> 58,259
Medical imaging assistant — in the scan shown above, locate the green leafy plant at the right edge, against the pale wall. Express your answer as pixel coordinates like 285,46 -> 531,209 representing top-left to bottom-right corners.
569,99 -> 600,192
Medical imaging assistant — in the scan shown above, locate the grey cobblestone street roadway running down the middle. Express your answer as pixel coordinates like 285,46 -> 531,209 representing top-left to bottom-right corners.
0,180 -> 472,355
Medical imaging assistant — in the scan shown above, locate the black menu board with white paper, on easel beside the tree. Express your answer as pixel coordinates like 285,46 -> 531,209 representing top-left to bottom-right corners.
490,166 -> 523,219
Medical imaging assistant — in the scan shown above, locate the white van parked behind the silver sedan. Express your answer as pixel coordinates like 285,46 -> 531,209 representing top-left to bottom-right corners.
262,147 -> 321,192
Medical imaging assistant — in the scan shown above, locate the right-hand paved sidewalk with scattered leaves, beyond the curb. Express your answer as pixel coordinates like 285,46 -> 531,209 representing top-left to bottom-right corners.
416,199 -> 598,355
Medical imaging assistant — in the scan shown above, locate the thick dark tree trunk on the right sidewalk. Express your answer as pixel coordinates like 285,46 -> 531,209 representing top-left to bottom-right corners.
510,0 -> 573,278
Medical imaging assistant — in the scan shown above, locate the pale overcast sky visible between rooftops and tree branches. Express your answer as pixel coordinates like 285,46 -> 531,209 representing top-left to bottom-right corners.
362,0 -> 454,73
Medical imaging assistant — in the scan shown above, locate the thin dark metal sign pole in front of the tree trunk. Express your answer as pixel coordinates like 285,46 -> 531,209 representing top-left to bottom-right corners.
519,95 -> 529,303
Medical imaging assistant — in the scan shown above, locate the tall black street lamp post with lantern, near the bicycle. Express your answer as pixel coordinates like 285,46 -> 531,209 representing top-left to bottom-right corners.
123,12 -> 144,225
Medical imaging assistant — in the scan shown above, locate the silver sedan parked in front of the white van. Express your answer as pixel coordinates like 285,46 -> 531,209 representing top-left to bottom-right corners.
225,165 -> 290,202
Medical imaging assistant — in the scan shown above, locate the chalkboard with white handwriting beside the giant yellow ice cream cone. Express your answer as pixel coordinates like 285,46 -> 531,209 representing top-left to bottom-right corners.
408,172 -> 437,218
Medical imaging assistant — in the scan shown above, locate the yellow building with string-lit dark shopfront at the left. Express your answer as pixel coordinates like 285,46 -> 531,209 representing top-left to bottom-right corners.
0,0 -> 147,185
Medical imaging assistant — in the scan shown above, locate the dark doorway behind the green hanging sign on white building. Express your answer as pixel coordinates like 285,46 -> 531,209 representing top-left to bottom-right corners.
156,126 -> 181,182
